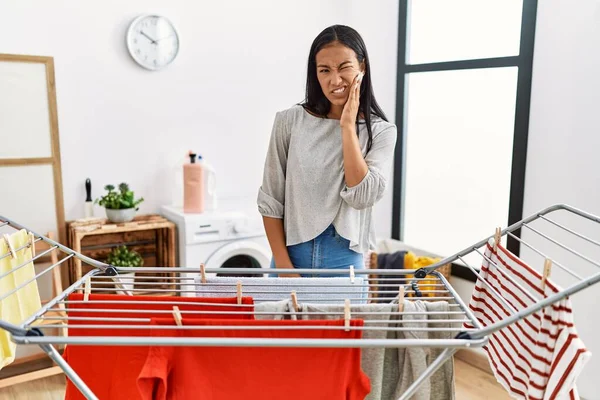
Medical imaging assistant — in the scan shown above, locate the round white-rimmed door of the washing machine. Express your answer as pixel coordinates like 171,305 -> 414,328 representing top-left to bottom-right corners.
205,240 -> 271,277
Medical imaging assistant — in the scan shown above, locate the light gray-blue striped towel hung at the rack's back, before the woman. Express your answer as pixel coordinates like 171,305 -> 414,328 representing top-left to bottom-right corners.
195,277 -> 368,304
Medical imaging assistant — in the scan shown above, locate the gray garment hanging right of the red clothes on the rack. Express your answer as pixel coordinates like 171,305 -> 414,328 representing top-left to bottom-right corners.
300,300 -> 460,400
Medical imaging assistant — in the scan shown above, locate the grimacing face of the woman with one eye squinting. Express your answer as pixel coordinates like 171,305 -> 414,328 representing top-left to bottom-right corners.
316,42 -> 364,106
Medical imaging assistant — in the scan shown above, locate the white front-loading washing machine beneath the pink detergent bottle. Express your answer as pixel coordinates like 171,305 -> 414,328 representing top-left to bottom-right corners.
161,206 -> 272,296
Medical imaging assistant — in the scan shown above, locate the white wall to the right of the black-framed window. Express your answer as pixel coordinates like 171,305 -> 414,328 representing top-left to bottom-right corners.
524,0 -> 600,399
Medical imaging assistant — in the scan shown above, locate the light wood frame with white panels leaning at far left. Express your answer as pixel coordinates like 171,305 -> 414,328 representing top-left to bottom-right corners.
0,54 -> 66,243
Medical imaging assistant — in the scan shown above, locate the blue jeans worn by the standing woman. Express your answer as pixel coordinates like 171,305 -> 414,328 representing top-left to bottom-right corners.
271,225 -> 364,277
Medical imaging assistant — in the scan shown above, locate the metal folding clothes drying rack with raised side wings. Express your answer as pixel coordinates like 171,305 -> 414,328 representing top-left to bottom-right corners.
0,205 -> 600,400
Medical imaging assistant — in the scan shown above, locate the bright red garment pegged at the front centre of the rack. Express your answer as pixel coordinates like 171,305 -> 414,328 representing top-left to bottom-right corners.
138,319 -> 371,400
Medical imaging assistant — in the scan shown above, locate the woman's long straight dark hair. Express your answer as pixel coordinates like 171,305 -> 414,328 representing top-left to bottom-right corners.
301,25 -> 388,152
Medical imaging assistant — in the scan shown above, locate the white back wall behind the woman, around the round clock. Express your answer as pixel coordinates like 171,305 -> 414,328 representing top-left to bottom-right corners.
0,0 -> 398,241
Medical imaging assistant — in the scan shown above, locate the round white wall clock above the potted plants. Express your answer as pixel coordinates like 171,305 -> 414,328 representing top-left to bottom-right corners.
127,15 -> 179,71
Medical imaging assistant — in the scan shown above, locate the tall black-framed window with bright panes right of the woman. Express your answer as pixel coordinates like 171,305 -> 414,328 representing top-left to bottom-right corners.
392,0 -> 537,267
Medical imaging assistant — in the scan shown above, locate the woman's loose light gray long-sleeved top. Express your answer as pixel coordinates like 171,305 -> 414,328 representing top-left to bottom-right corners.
257,106 -> 396,253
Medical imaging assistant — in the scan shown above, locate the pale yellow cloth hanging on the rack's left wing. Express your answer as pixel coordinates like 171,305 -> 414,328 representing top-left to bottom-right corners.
0,229 -> 42,368
